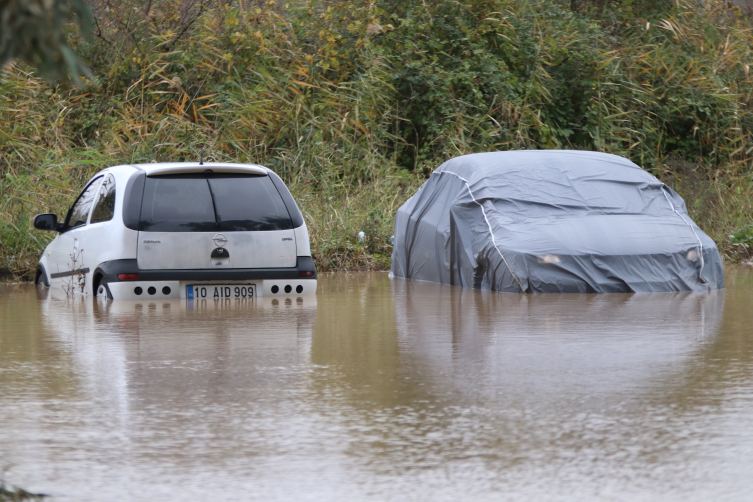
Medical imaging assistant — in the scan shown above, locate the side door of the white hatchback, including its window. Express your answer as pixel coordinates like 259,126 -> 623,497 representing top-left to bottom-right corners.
47,175 -> 103,294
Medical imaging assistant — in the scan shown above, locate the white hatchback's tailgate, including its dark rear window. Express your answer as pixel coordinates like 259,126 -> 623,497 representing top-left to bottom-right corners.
137,172 -> 296,270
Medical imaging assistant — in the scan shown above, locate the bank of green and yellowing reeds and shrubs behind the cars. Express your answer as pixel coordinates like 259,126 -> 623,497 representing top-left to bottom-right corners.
0,0 -> 753,277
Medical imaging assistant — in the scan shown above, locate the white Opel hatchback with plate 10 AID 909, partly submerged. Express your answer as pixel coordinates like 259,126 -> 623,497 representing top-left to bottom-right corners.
34,163 -> 317,299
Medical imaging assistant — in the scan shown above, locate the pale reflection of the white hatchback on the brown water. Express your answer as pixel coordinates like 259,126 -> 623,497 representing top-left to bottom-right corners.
42,290 -> 316,426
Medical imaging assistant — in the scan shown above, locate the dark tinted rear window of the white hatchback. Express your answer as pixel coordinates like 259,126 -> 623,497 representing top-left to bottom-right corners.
139,173 -> 293,232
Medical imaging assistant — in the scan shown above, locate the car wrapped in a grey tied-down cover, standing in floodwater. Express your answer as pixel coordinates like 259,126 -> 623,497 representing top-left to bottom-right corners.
392,150 -> 724,293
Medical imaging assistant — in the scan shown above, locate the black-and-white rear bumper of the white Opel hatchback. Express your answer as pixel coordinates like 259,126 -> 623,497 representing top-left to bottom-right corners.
94,256 -> 317,300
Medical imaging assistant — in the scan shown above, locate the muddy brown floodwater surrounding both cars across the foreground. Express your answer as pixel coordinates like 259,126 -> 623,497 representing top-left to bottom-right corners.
0,266 -> 753,502
